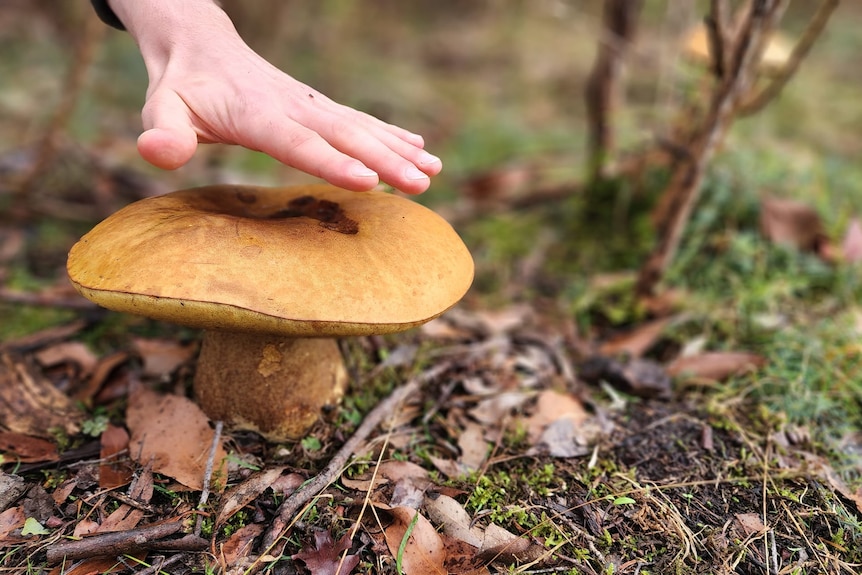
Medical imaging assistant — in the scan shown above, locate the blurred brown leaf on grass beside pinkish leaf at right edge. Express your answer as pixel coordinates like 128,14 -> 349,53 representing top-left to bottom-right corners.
760,196 -> 826,252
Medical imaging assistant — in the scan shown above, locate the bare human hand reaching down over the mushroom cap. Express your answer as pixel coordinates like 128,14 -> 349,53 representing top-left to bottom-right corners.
111,0 -> 442,194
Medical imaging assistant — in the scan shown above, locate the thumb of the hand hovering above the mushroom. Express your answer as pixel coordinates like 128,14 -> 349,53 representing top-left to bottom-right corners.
138,92 -> 198,170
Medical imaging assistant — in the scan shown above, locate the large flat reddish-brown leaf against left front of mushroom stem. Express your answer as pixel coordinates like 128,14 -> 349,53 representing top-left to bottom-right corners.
126,387 -> 227,490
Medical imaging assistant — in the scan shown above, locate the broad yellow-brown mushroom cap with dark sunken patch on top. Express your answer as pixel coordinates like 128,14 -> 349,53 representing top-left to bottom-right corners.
67,185 -> 473,337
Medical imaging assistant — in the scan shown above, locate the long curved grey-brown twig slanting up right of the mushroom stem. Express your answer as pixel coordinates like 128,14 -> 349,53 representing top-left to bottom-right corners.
263,363 -> 449,549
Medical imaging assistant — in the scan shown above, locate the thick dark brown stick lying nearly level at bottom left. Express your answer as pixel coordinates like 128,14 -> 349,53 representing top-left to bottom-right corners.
47,521 -> 209,565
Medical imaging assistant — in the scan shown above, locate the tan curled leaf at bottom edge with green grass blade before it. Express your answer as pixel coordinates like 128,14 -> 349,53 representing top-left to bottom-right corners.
384,506 -> 447,575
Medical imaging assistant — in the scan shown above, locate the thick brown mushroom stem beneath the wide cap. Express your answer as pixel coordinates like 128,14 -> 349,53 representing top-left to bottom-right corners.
194,330 -> 347,442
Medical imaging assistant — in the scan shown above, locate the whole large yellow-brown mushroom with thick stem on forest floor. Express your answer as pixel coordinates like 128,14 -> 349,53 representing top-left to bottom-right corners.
67,185 -> 473,441
